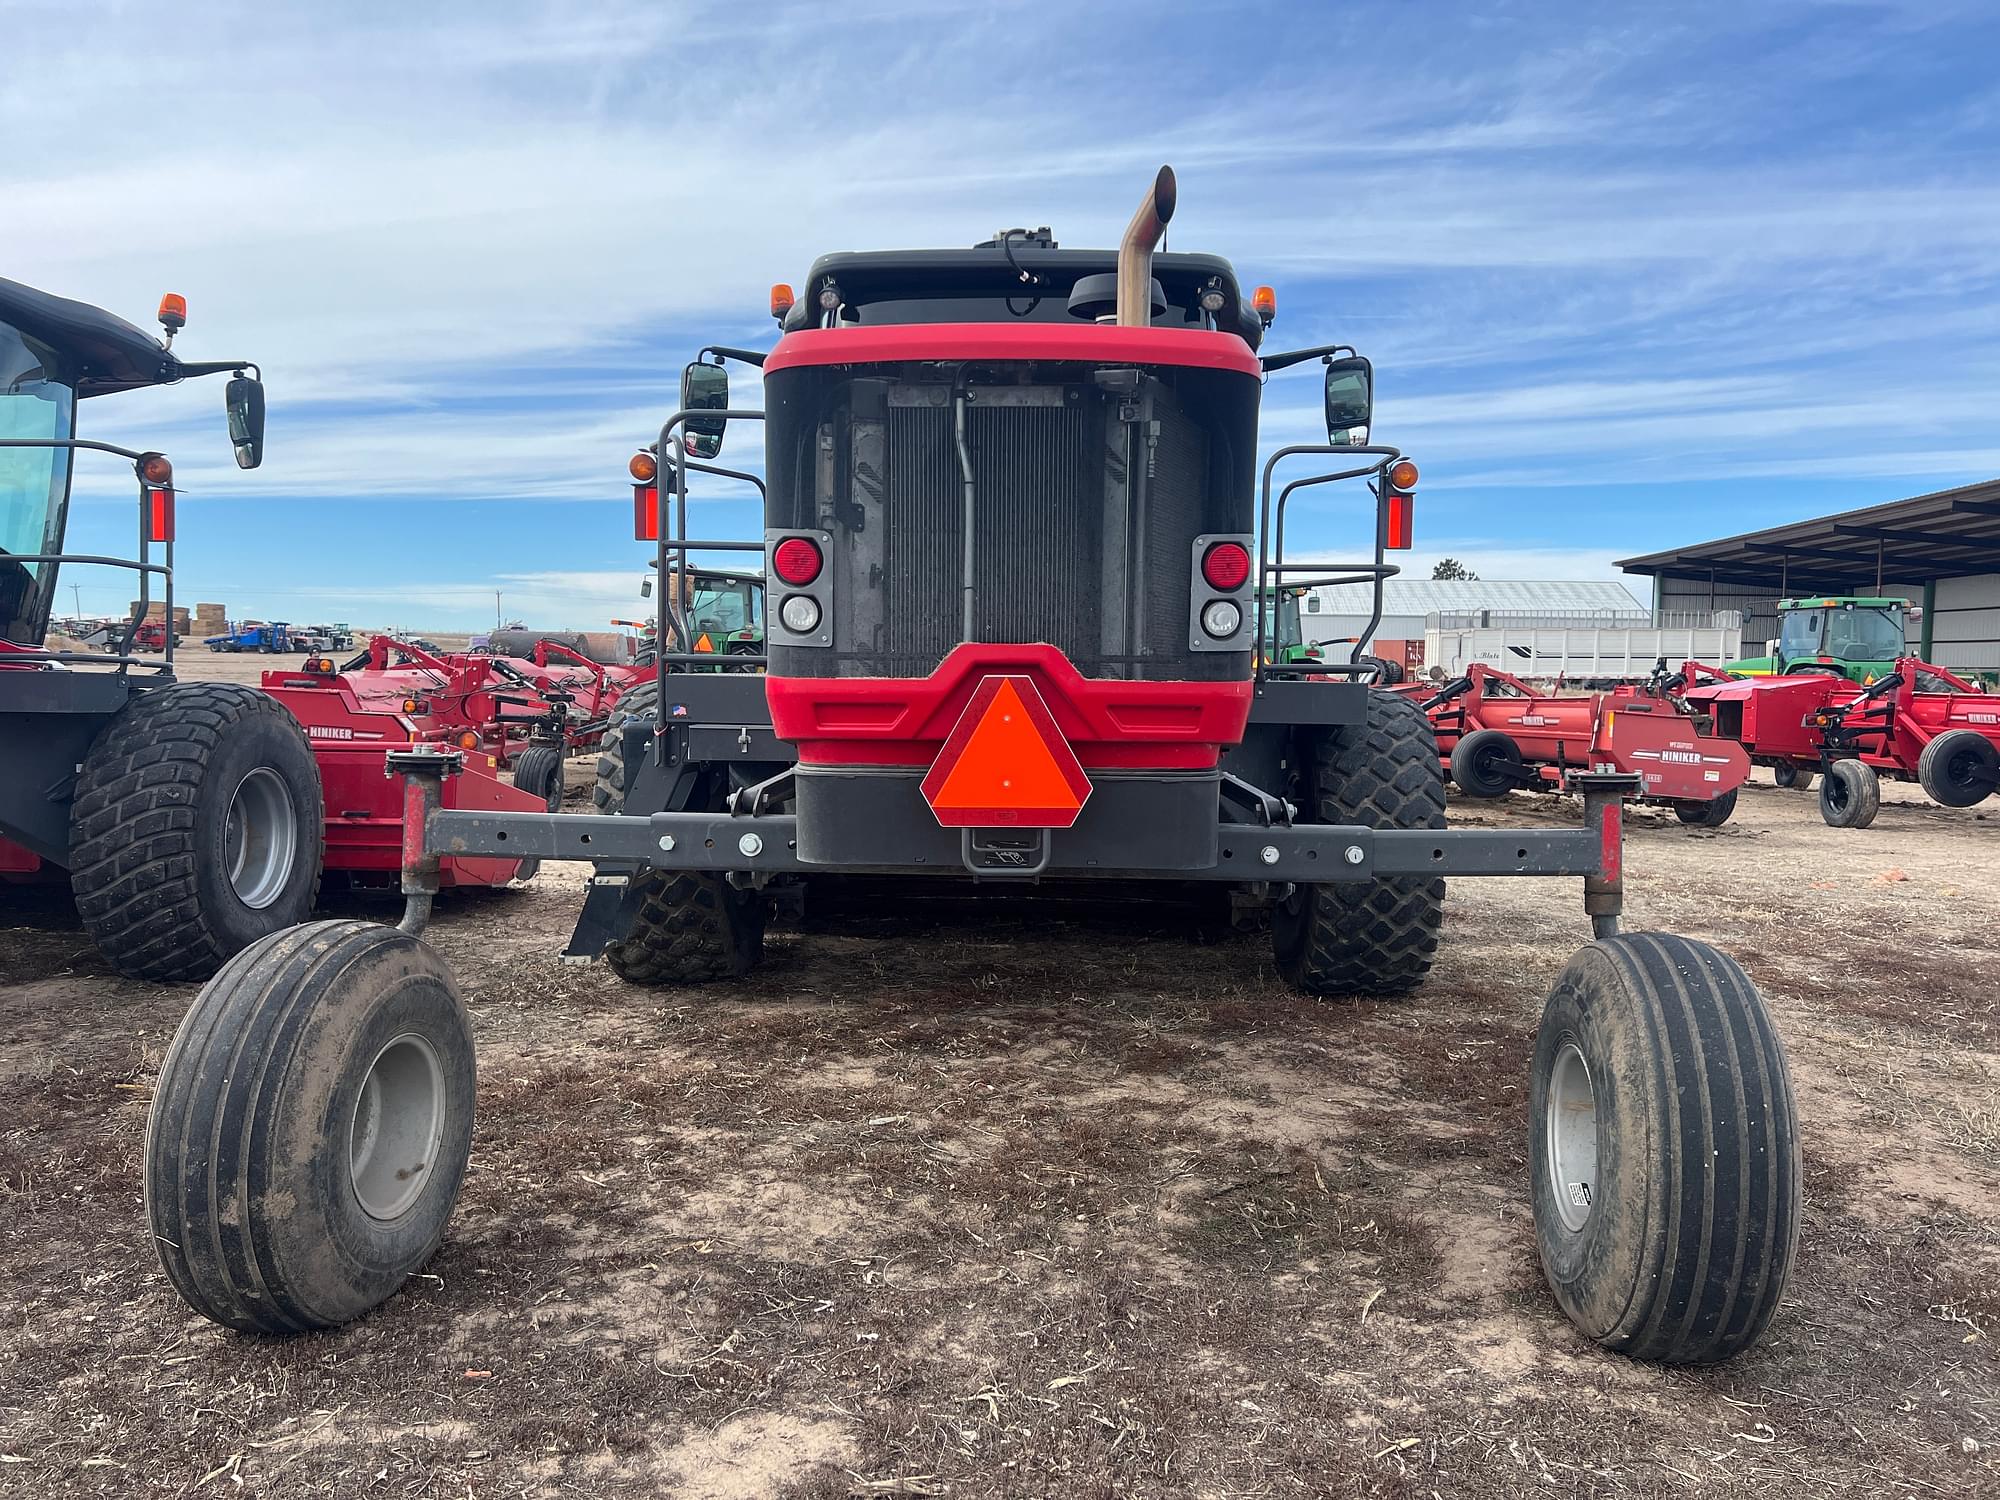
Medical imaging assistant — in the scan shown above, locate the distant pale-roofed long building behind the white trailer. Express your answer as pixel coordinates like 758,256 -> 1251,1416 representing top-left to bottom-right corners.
1300,578 -> 1652,654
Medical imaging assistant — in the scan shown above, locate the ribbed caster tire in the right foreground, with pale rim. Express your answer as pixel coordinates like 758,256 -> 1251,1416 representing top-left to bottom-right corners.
1528,932 -> 1800,1364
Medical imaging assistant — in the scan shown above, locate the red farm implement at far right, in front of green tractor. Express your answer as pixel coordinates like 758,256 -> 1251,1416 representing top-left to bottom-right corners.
1684,656 -> 2000,828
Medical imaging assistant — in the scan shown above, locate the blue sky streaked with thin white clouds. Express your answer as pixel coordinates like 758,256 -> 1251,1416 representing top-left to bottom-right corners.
11,0 -> 2000,630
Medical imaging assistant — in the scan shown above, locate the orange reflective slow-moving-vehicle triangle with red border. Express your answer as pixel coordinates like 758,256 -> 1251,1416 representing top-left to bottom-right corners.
924,676 -> 1090,828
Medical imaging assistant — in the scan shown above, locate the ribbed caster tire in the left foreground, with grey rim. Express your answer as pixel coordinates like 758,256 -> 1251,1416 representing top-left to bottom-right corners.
146,922 -> 476,1334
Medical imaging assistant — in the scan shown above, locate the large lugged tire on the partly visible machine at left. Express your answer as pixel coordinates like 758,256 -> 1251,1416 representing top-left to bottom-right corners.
70,682 -> 326,980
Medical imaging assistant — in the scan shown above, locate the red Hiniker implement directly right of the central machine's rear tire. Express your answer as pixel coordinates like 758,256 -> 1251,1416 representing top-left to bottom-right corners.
1402,664 -> 1750,828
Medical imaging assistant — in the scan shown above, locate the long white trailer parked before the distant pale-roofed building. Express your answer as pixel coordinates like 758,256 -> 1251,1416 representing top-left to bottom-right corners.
1424,610 -> 1744,688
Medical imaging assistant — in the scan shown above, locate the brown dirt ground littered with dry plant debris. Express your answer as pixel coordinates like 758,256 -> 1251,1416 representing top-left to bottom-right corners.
0,712 -> 2000,1500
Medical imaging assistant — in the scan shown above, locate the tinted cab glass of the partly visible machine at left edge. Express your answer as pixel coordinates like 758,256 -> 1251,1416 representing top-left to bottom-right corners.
0,324 -> 76,644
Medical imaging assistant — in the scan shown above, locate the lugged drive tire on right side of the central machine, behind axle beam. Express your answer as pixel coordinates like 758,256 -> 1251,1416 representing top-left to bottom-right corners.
1270,692 -> 1444,994
